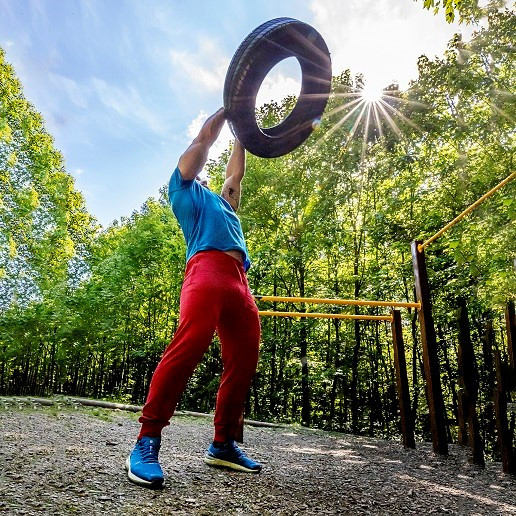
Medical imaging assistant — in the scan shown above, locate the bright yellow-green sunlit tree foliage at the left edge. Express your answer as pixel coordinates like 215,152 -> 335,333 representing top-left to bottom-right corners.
0,47 -> 96,310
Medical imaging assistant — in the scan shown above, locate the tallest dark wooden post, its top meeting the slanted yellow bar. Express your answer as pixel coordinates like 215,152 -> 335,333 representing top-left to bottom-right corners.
411,241 -> 448,455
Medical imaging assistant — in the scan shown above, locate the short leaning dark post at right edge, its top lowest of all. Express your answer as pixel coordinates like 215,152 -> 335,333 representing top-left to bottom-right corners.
494,350 -> 516,474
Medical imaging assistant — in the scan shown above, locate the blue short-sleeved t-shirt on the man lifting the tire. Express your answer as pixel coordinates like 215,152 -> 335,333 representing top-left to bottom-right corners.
168,168 -> 251,271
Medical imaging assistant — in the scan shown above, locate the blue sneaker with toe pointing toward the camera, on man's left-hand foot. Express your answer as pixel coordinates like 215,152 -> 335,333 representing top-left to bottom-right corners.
125,436 -> 165,489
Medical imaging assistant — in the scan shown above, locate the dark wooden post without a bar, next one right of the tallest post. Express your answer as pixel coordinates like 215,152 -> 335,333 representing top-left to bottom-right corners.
458,299 -> 485,468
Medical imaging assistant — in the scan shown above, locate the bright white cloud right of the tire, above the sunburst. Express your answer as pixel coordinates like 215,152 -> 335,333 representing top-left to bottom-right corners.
310,0 -> 471,88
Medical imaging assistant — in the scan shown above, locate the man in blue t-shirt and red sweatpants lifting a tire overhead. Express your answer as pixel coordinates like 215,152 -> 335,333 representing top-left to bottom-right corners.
126,108 -> 261,488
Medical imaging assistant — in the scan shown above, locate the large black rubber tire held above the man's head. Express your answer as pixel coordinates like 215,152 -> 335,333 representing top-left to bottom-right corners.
224,18 -> 331,158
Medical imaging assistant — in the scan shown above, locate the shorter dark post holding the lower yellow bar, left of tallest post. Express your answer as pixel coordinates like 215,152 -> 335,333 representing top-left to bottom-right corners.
391,310 -> 416,448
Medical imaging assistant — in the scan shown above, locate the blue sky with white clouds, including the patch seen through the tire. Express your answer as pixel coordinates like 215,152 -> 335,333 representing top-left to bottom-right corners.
0,0 -> 471,227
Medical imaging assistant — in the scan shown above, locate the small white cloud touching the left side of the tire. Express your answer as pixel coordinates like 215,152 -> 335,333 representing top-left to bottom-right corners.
170,37 -> 229,92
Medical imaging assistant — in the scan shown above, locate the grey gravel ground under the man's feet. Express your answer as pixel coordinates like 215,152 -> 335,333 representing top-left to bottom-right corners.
0,403 -> 516,515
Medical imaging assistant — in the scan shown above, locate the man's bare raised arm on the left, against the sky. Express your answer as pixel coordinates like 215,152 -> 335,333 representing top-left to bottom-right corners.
177,108 -> 226,181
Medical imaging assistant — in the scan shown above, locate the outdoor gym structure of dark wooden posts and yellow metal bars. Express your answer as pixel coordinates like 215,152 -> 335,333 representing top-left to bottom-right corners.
255,172 -> 516,474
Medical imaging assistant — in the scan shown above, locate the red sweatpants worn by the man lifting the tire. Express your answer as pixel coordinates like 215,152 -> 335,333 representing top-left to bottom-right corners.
139,251 -> 260,441
